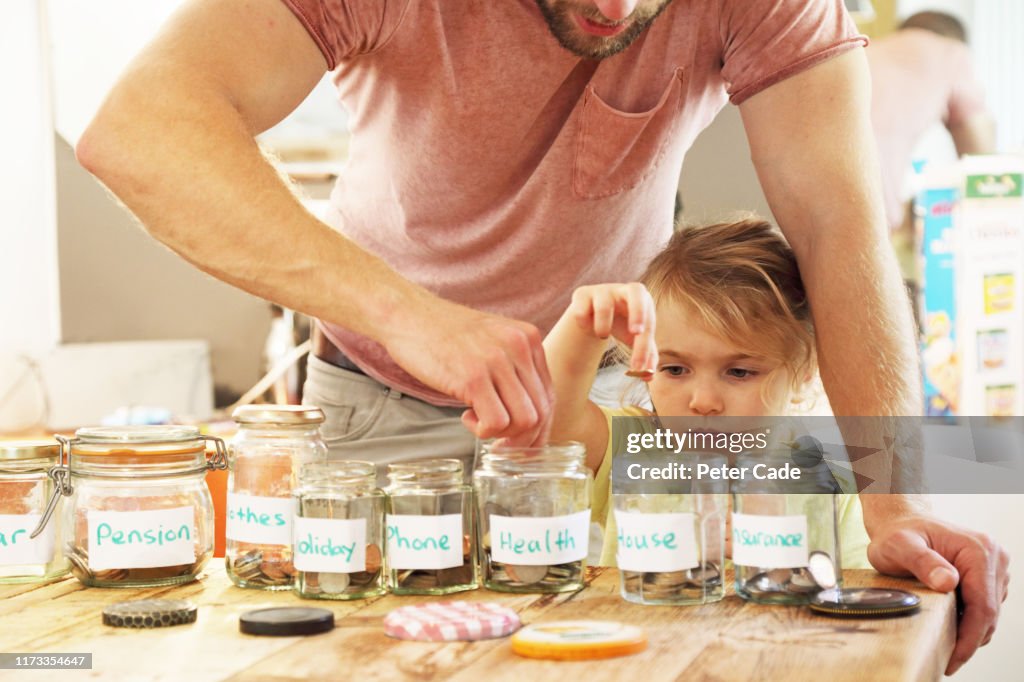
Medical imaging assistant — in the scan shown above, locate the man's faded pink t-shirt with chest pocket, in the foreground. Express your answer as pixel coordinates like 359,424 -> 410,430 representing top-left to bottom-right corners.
284,0 -> 866,406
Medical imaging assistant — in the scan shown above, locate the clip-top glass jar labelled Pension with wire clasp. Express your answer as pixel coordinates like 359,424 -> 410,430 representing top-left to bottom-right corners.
34,426 -> 227,588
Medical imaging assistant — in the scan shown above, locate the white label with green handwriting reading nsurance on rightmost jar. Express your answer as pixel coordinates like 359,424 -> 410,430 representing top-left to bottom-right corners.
732,513 -> 807,568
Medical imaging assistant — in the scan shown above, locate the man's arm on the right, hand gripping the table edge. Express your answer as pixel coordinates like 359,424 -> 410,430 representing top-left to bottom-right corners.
740,50 -> 1009,674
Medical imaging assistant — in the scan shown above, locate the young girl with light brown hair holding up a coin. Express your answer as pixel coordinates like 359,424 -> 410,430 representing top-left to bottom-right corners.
544,218 -> 869,568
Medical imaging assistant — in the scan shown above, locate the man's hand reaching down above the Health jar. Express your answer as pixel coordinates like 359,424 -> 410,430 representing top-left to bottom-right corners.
382,298 -> 554,446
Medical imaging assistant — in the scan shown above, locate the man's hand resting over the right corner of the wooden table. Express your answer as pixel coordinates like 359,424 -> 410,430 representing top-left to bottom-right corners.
867,515 -> 1010,675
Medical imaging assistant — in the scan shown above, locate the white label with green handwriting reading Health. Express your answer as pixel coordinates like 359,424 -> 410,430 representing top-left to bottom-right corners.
490,510 -> 590,566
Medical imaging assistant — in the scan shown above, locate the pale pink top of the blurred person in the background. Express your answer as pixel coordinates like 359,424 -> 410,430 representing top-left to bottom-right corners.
867,29 -> 985,229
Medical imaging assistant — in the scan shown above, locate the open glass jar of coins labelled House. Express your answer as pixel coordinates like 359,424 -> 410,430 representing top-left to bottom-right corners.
612,453 -> 729,605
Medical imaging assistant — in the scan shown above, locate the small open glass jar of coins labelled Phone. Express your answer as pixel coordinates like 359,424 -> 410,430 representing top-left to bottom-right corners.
385,460 -> 479,594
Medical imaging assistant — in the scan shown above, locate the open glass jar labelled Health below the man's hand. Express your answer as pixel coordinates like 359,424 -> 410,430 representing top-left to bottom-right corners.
473,442 -> 594,592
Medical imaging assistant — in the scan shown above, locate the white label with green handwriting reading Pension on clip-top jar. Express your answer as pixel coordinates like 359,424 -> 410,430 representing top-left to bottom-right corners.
88,507 -> 196,570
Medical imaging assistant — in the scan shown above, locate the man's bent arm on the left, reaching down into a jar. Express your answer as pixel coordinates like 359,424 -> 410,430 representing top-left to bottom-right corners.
77,0 -> 551,443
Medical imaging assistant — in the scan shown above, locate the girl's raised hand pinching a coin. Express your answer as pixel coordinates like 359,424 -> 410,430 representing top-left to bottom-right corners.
566,282 -> 657,381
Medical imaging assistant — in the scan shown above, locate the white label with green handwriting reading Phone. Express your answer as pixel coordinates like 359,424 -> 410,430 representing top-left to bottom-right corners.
387,514 -> 463,569
